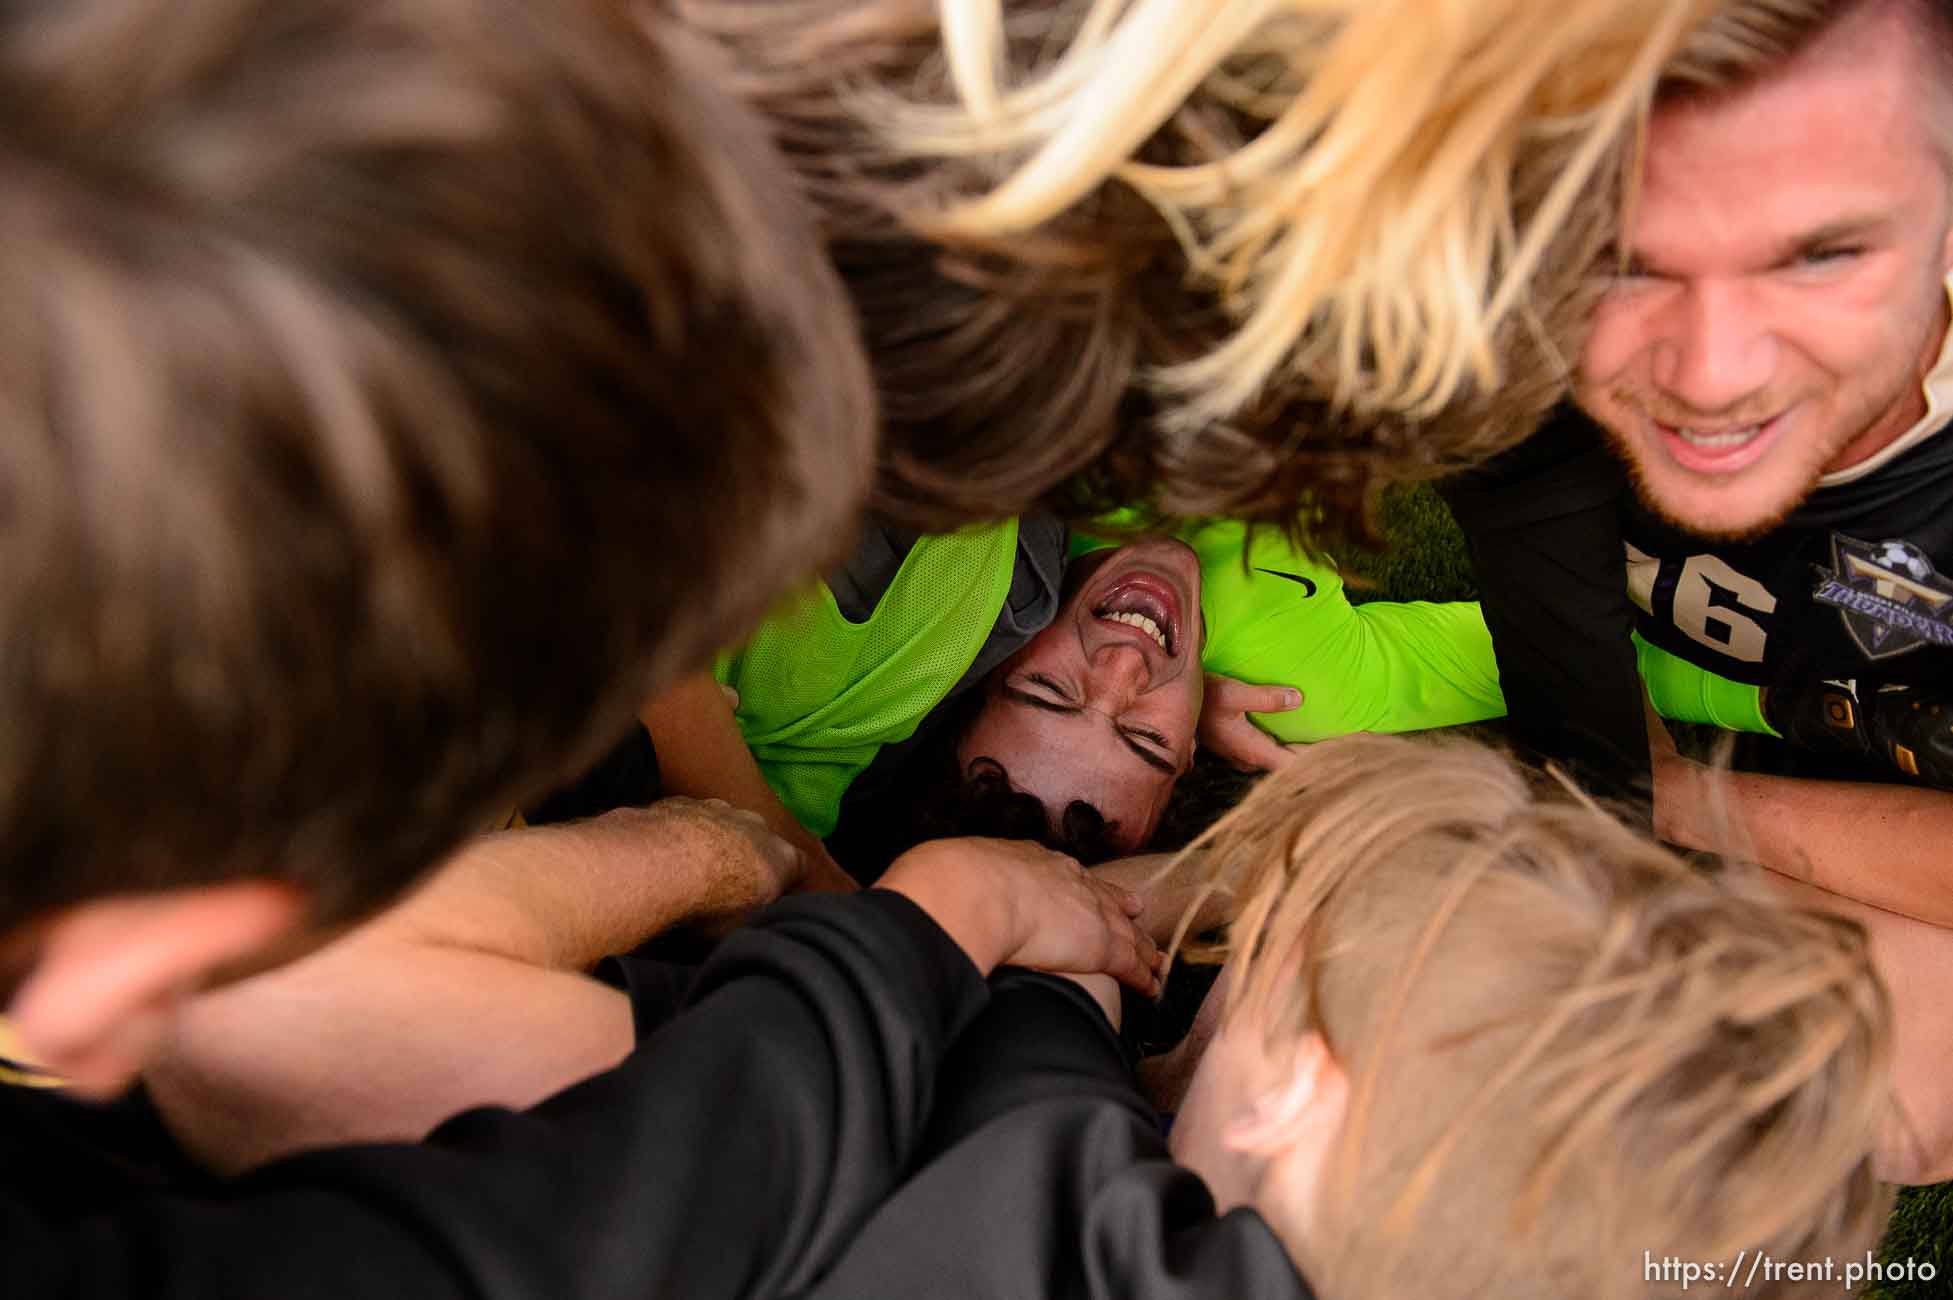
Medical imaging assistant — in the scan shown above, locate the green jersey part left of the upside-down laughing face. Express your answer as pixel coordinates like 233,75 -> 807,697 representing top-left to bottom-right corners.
713,519 -> 1018,837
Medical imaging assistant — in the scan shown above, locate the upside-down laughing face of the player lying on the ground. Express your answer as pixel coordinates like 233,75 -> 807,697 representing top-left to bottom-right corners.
957,539 -> 1205,851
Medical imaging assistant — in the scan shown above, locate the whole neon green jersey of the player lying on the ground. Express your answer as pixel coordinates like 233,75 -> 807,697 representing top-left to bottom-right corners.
717,521 -> 1764,835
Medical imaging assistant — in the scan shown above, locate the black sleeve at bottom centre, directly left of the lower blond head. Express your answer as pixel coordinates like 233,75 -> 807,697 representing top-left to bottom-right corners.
810,972 -> 1312,1300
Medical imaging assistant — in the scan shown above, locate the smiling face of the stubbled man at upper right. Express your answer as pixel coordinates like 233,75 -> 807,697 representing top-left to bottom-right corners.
1578,4 -> 1953,537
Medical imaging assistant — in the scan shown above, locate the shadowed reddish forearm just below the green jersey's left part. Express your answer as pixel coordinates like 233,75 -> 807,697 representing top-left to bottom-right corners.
639,673 -> 859,892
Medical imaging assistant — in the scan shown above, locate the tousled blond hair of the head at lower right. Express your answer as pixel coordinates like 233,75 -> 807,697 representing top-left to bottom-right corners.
1171,736 -> 1891,1300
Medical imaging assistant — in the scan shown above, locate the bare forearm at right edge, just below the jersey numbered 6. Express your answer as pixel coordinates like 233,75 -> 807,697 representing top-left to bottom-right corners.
1654,757 -> 1953,925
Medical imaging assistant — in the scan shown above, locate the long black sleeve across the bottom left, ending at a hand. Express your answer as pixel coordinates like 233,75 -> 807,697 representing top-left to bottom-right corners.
0,890 -> 986,1300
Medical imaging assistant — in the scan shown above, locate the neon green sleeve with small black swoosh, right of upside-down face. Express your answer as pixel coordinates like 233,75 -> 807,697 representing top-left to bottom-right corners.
1072,519 -> 1506,742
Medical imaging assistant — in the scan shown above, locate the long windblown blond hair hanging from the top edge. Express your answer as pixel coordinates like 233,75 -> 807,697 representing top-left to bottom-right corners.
869,0 -> 1713,427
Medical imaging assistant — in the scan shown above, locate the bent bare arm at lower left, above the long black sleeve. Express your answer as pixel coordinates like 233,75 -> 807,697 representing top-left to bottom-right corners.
146,798 -> 799,1171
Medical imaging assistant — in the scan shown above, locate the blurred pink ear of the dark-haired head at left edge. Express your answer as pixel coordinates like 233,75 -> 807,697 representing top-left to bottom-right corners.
8,880 -> 303,1097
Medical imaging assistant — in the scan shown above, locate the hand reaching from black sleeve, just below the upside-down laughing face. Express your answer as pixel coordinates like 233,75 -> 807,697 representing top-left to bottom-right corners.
881,839 -> 1162,995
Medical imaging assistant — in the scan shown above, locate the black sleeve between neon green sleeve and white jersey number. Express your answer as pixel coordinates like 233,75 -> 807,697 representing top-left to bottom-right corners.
1439,408 -> 1648,794
